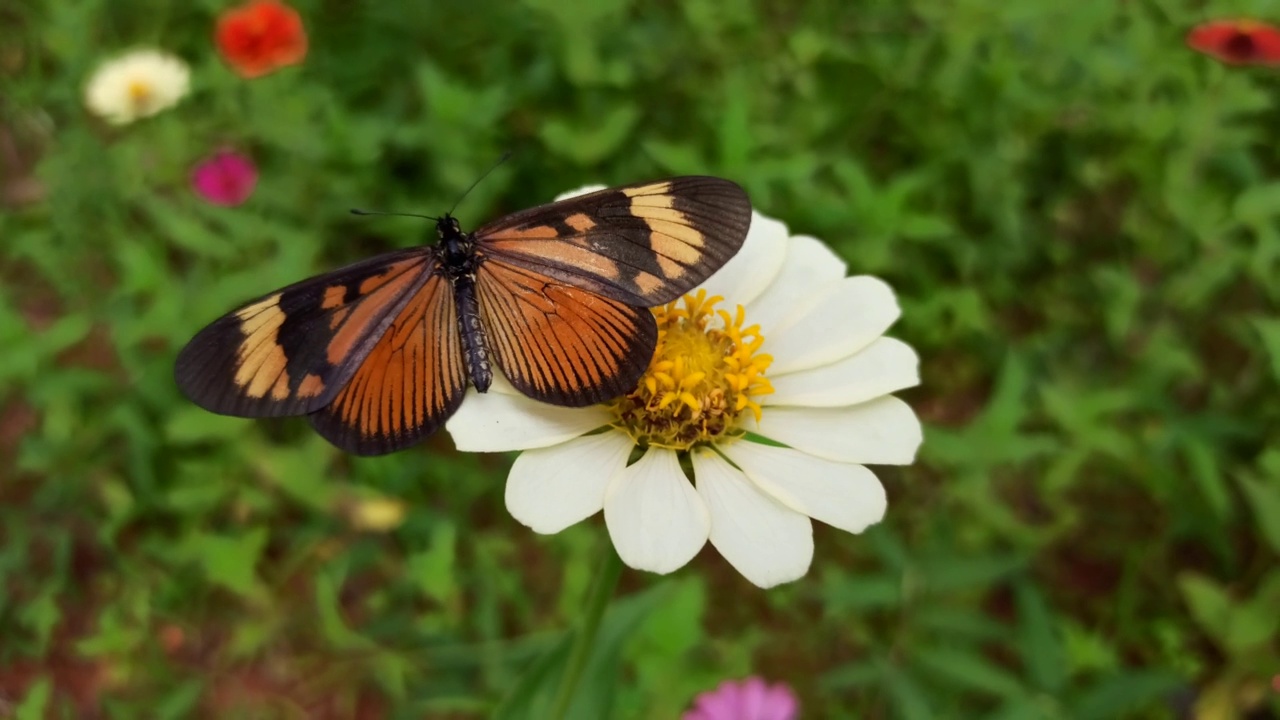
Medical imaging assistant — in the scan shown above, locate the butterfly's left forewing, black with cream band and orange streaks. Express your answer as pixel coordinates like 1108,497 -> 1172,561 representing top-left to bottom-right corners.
174,249 -> 436,418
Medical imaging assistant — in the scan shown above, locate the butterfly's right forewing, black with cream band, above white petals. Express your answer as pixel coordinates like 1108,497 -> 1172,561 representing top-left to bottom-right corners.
475,176 -> 751,307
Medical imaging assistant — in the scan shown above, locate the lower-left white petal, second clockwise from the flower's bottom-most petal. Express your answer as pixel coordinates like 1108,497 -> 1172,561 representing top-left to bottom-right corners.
507,430 -> 634,533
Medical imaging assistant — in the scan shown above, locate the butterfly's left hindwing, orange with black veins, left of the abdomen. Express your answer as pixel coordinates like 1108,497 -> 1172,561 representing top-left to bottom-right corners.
311,268 -> 467,455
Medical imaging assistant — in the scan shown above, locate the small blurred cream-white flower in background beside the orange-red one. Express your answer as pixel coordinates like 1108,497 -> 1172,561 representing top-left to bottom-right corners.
84,50 -> 191,126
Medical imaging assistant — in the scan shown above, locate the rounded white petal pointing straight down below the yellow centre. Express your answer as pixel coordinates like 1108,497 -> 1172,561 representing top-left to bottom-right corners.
604,448 -> 710,573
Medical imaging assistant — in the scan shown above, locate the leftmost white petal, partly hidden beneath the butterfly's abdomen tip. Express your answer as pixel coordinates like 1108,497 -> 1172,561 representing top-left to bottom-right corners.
444,388 -> 613,452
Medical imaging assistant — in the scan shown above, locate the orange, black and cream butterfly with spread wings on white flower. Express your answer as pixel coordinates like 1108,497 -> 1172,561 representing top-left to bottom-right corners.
174,177 -> 751,455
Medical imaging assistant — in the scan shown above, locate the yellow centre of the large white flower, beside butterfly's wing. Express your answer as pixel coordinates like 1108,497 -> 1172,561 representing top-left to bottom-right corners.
612,290 -> 773,450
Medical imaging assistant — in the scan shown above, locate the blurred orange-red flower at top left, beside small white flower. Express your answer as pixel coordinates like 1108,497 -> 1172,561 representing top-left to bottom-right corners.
215,0 -> 307,78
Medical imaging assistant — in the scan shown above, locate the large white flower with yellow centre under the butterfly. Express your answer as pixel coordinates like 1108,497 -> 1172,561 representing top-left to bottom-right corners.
448,187 -> 922,587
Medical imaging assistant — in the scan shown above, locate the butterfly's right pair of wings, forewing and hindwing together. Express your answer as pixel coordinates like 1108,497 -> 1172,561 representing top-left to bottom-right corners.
475,177 -> 751,406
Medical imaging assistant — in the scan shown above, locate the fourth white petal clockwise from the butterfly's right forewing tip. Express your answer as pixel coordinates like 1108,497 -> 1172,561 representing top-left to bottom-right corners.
764,337 -> 920,407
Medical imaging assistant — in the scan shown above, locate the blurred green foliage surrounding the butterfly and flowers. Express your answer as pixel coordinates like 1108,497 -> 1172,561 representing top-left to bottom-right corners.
0,0 -> 1280,719
